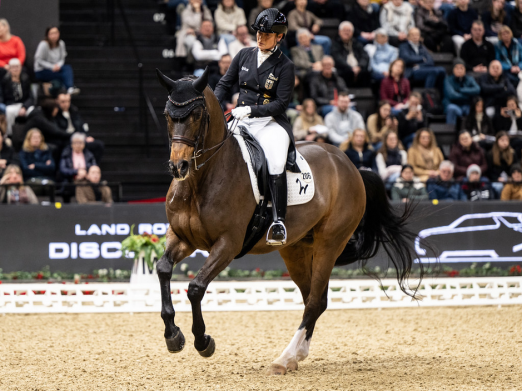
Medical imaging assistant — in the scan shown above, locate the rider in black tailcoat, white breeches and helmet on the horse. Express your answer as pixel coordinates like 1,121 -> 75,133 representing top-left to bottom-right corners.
214,8 -> 299,245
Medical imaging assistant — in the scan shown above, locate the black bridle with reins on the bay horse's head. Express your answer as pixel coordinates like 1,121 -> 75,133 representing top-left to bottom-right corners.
168,95 -> 239,171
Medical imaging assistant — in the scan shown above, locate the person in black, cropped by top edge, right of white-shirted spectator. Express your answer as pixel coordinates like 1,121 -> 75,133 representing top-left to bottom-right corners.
415,0 -> 454,53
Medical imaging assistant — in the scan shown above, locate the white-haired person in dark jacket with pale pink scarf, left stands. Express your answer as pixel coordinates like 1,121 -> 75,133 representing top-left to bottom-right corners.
60,133 -> 96,182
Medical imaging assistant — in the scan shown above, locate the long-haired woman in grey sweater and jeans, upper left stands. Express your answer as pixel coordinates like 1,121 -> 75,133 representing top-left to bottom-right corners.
34,26 -> 80,95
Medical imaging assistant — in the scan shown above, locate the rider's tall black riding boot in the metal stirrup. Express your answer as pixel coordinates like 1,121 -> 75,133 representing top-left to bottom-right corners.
267,171 -> 288,246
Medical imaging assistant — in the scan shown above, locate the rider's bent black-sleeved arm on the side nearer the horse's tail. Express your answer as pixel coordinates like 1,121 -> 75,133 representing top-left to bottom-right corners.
250,63 -> 295,117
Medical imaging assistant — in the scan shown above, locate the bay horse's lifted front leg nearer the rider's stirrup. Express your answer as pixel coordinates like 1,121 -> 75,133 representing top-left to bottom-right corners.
187,239 -> 236,357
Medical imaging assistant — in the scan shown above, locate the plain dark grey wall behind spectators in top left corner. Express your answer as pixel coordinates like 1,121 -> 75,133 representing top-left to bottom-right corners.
0,0 -> 60,69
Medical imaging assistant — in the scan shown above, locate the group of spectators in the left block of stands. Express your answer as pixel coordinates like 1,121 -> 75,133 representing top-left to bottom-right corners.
0,19 -> 112,204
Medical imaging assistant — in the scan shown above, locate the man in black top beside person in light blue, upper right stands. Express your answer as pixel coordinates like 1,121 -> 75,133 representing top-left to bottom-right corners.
460,20 -> 495,76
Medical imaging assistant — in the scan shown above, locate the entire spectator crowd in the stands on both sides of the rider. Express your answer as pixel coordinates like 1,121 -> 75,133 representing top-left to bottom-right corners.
0,0 -> 522,202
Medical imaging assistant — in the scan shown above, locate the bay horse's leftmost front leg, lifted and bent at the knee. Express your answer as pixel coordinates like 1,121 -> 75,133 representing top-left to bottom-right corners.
157,227 -> 193,353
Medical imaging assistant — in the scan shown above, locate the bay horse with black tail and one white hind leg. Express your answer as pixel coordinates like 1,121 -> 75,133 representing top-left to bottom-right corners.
153,70 -> 415,375
